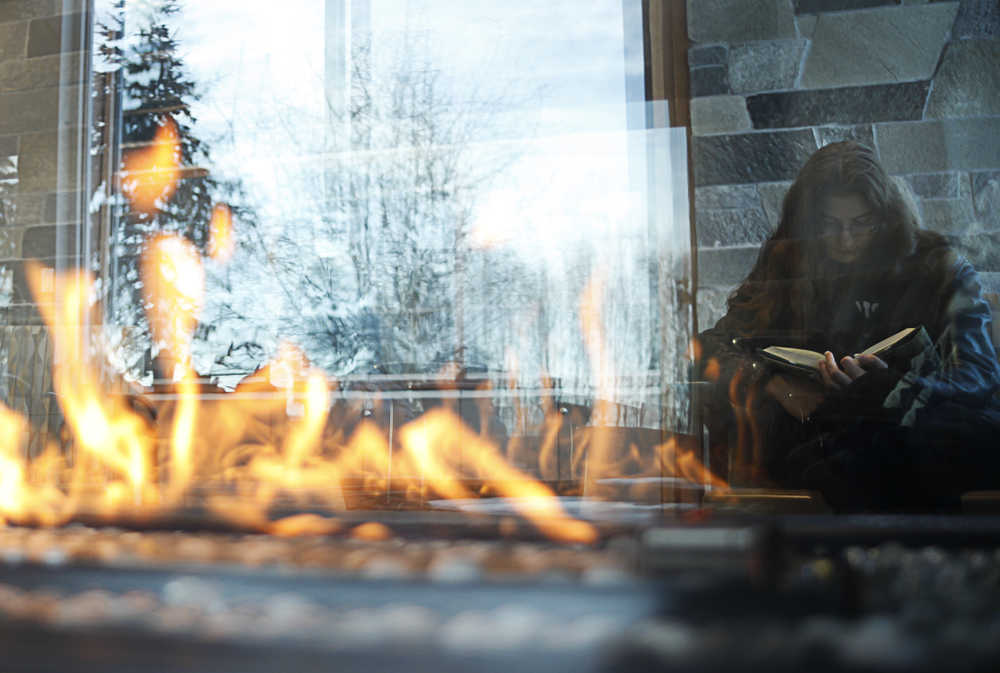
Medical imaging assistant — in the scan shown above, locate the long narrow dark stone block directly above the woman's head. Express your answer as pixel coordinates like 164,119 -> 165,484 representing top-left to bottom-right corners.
747,81 -> 930,129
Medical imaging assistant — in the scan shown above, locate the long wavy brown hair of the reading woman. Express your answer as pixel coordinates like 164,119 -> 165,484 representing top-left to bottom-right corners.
728,142 -> 932,335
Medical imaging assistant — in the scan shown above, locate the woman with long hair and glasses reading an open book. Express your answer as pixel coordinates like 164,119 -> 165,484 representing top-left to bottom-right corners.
700,142 -> 1000,509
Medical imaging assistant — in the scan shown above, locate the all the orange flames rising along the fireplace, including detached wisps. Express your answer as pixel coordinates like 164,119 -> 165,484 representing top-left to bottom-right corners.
0,118 -> 726,544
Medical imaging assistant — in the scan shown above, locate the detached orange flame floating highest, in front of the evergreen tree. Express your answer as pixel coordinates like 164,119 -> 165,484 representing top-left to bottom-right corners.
121,117 -> 181,213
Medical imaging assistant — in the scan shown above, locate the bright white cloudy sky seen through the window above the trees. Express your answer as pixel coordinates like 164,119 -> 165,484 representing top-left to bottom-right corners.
103,0 -> 690,388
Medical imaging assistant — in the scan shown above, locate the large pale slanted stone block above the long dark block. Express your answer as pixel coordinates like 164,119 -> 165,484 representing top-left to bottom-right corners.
800,2 -> 958,89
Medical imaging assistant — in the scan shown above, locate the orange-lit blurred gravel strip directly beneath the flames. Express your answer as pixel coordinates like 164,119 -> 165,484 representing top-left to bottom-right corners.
0,522 -> 635,585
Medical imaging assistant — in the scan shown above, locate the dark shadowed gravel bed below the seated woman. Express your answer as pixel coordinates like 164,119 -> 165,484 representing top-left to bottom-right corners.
616,543 -> 1000,672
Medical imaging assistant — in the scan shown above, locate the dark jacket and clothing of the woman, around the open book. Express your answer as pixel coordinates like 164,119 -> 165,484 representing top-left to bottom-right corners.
699,238 -> 1000,508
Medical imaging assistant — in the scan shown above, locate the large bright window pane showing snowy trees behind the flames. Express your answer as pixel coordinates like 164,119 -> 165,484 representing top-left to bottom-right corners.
97,0 -> 690,440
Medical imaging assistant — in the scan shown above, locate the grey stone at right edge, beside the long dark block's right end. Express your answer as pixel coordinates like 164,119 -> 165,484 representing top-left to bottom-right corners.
926,40 -> 1000,119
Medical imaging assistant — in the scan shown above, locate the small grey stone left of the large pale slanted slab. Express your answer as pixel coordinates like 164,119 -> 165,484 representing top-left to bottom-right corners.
729,40 -> 807,93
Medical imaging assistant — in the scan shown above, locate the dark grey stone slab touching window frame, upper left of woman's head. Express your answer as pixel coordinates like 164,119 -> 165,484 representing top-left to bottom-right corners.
692,130 -> 816,186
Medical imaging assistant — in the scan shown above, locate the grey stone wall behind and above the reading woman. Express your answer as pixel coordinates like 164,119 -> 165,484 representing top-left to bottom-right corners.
687,0 -> 1000,329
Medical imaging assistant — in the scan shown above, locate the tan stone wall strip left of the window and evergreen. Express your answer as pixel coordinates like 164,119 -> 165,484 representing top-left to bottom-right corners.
0,0 -> 87,449
